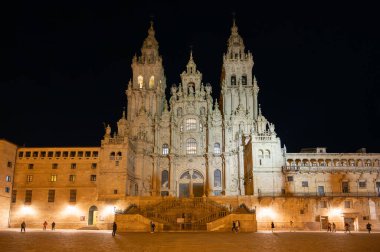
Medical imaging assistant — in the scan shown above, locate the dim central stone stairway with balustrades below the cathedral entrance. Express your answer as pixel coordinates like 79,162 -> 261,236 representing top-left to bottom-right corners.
124,197 -> 230,231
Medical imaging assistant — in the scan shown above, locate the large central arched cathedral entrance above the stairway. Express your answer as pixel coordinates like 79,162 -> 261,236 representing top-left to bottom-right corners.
178,170 -> 204,198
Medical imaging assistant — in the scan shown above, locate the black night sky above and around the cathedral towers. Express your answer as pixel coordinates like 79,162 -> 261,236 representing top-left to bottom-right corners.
0,0 -> 380,152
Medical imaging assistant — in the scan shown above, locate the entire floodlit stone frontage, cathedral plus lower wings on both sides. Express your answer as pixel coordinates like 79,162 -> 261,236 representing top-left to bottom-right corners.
0,23 -> 380,230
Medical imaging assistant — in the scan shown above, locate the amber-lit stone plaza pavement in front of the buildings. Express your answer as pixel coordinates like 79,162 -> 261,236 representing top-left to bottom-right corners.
0,229 -> 380,252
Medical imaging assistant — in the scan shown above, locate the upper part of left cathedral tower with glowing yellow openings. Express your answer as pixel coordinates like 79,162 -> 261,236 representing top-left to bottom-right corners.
126,22 -> 166,121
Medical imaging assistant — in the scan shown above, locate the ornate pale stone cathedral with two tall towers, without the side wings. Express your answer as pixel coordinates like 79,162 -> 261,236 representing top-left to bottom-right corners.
99,21 -> 284,197
